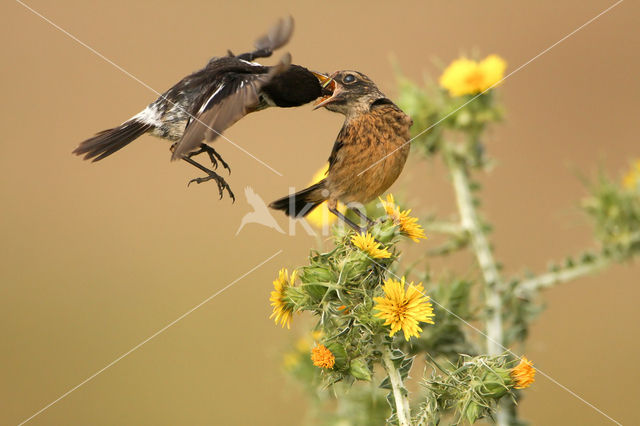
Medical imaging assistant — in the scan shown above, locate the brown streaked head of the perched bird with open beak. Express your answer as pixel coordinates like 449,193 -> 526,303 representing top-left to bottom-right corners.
314,70 -> 386,115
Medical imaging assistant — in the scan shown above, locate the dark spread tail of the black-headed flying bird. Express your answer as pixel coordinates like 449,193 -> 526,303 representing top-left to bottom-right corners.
73,120 -> 153,161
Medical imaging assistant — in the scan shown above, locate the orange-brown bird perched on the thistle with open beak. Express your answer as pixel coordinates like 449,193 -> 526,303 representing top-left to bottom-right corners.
269,71 -> 413,232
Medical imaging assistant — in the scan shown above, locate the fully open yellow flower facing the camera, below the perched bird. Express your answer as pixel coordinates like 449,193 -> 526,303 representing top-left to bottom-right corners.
373,277 -> 435,341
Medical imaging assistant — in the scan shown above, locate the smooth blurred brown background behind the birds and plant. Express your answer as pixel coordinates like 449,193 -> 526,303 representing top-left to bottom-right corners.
0,0 -> 640,425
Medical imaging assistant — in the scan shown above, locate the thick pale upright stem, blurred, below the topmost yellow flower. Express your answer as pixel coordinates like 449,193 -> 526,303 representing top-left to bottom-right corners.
446,150 -> 511,426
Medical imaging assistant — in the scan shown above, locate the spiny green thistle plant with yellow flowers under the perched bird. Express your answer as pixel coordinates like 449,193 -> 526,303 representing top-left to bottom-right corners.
270,55 -> 640,425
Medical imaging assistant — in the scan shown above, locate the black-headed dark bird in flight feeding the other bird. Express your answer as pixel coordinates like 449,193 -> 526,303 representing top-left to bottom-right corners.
73,17 -> 328,200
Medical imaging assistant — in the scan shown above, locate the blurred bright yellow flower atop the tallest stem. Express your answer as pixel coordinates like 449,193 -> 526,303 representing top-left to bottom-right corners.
440,55 -> 507,96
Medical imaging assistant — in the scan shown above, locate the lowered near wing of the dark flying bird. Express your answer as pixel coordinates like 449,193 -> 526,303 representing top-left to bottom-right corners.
172,53 -> 291,160
